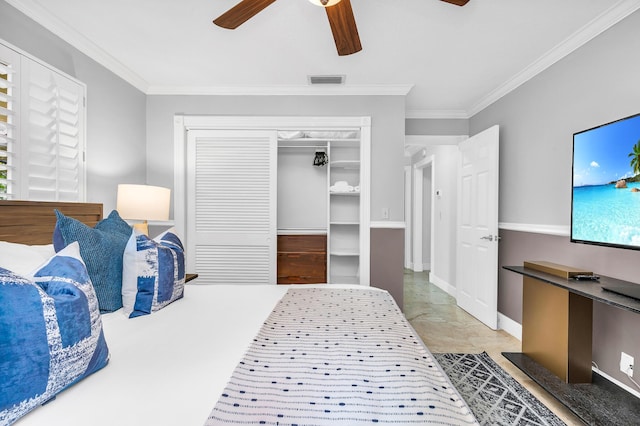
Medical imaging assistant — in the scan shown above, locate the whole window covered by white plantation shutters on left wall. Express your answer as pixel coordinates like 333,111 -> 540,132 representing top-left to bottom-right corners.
0,40 -> 86,201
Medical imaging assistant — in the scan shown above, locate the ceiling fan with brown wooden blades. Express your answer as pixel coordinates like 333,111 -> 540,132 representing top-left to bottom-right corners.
213,0 -> 469,56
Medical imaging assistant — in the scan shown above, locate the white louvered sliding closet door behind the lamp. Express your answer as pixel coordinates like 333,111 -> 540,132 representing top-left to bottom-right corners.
187,130 -> 277,284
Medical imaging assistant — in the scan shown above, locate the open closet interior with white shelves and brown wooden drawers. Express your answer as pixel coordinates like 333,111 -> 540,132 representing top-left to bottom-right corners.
277,130 -> 361,284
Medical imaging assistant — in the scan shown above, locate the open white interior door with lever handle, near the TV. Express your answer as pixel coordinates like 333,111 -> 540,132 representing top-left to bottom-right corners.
456,126 -> 499,330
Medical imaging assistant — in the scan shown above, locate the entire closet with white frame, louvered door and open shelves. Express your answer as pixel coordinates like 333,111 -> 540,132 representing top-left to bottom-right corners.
174,116 -> 370,285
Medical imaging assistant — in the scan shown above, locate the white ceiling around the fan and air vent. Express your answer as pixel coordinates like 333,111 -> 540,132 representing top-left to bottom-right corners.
6,0 -> 640,117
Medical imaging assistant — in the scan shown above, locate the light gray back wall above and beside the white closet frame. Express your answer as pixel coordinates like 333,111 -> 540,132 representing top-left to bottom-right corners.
147,96 -> 405,221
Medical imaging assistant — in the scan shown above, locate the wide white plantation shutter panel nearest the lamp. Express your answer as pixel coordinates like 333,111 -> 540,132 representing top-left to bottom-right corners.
20,57 -> 84,201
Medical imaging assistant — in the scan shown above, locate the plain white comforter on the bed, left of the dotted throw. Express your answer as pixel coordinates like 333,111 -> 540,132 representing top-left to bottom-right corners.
17,284 -> 364,426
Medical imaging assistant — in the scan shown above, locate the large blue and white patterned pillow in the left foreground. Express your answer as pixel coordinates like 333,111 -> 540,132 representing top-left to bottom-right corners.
0,243 -> 109,424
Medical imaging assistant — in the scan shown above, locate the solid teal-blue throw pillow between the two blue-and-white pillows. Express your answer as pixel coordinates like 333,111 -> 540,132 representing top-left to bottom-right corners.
53,210 -> 133,312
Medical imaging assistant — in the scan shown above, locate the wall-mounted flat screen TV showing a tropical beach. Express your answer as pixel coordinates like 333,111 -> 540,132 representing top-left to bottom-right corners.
571,114 -> 640,250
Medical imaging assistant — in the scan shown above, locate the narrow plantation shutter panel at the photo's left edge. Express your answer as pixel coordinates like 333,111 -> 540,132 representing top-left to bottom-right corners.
0,45 -> 20,200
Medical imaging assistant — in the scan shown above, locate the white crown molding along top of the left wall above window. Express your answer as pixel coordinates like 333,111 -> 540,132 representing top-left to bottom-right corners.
6,0 -> 149,93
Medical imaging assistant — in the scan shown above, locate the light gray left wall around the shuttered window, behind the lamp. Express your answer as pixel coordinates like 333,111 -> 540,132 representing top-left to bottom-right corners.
0,1 -> 146,213
